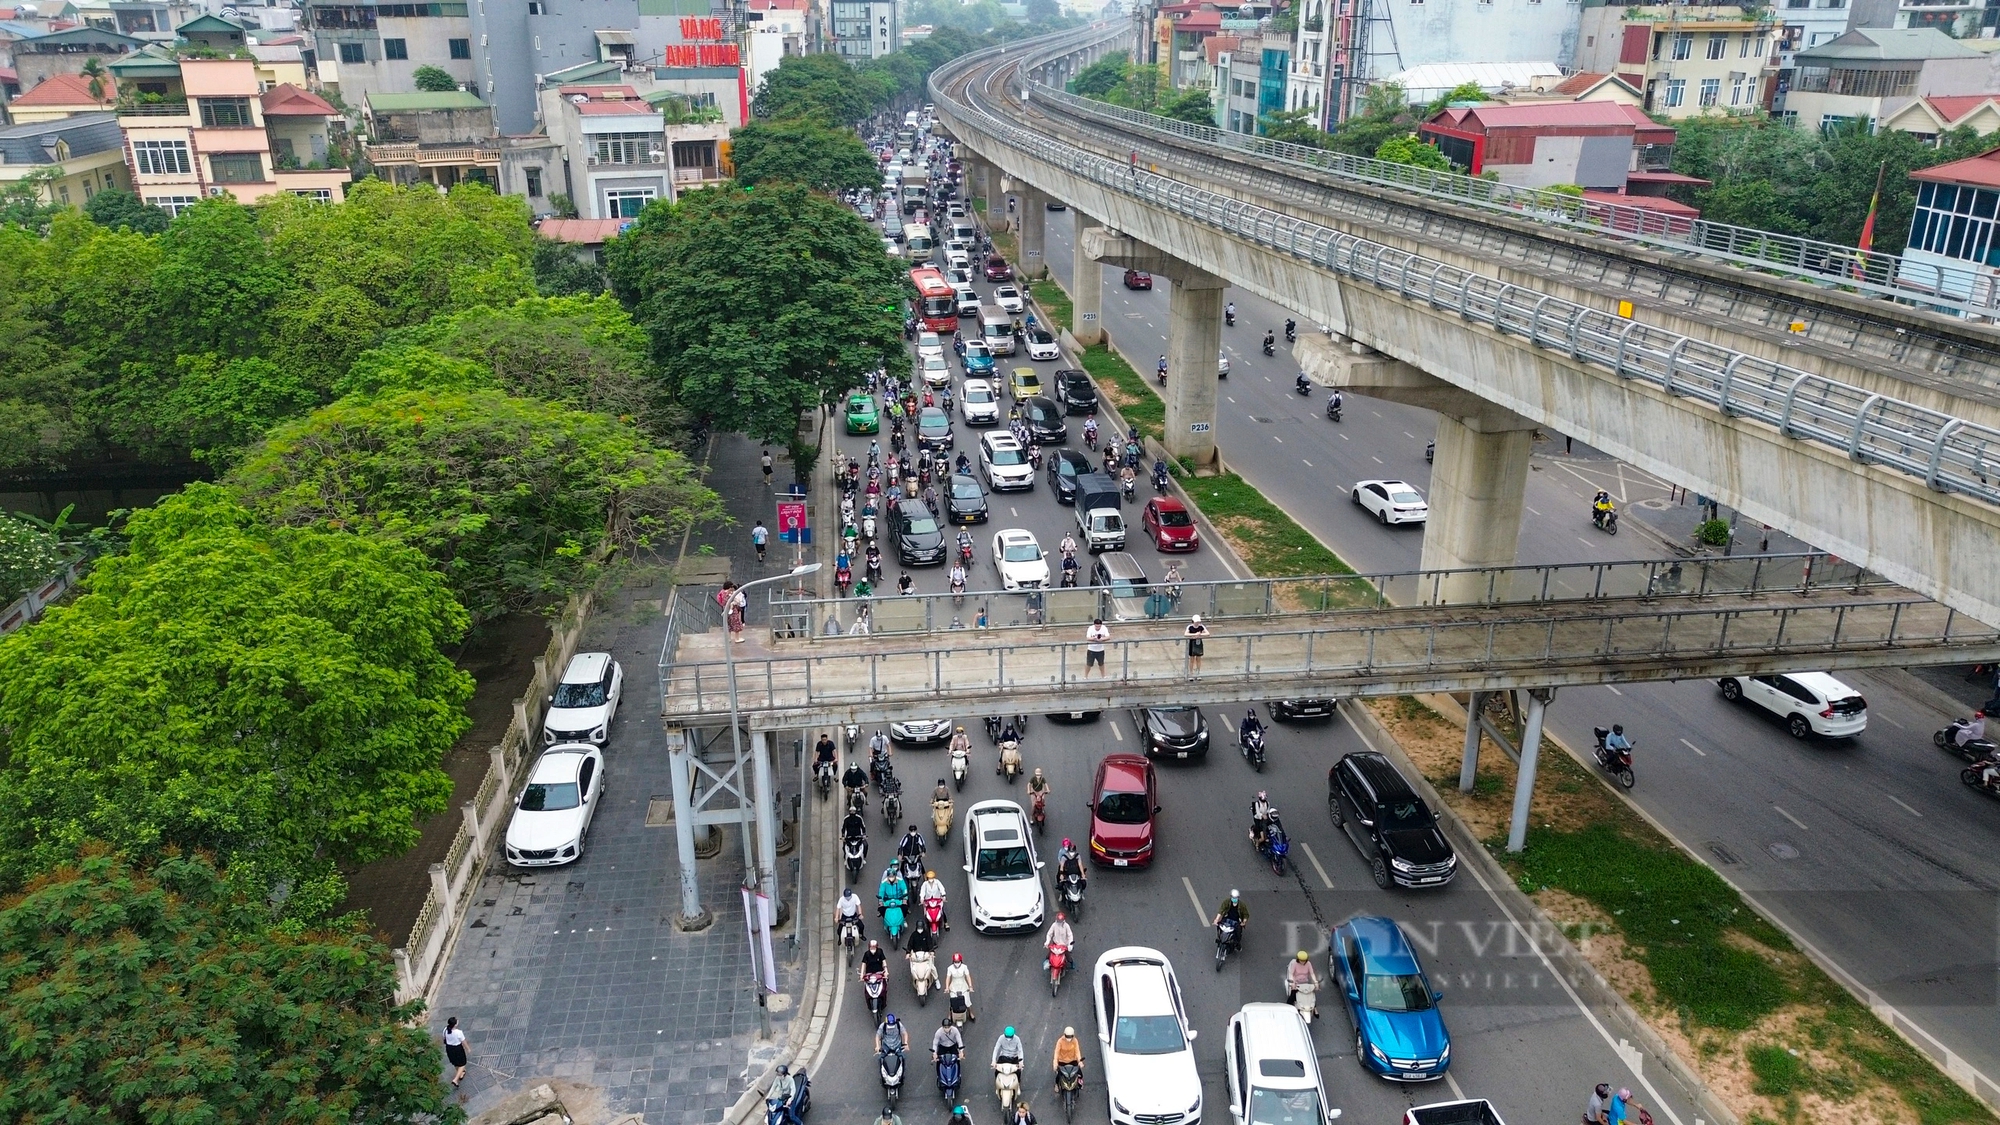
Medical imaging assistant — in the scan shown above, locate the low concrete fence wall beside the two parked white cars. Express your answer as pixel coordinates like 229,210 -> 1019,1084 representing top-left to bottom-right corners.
394,593 -> 592,1003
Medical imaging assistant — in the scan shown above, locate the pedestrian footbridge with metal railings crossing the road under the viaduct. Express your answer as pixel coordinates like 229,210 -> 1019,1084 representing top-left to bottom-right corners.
660,554 -> 2000,731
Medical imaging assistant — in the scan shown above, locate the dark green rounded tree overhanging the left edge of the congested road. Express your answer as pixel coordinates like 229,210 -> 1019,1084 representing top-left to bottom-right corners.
606,184 -> 910,462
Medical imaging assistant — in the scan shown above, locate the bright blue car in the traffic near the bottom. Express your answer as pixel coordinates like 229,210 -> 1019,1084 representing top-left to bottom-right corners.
1332,917 -> 1452,1083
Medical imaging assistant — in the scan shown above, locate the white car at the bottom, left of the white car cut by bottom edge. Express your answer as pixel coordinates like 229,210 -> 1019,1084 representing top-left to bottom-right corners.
1090,945 -> 1200,1125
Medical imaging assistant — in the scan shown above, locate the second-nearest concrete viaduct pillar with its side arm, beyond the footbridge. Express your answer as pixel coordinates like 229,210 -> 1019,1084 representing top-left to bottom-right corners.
1076,228 -> 1228,464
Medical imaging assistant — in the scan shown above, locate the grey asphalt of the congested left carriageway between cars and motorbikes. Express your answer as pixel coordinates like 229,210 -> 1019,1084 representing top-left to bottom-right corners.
796,197 -> 1694,1125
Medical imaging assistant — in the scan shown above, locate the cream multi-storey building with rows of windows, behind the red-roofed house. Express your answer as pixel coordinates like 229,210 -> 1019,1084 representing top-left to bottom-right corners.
1578,4 -> 1784,118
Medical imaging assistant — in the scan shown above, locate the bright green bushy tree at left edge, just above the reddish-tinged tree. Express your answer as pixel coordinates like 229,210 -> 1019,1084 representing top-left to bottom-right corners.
0,484 -> 472,897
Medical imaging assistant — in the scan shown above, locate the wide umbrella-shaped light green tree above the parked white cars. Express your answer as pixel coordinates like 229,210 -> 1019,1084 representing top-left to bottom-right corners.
228,382 -> 720,619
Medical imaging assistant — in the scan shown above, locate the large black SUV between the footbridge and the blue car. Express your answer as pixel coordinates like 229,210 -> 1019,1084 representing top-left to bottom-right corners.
1326,751 -> 1458,891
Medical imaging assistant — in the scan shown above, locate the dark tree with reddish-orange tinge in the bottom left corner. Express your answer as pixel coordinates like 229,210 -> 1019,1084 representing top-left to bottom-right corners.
0,847 -> 464,1125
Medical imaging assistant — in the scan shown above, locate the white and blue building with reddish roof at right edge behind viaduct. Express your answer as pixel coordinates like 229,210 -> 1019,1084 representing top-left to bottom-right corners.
1896,148 -> 2000,298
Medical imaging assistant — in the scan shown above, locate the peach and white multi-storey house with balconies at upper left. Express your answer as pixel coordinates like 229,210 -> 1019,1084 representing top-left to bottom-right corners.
110,44 -> 348,214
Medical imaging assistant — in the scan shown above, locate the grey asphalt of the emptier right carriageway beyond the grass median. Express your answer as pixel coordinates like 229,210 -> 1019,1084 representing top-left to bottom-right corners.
1046,212 -> 2000,1095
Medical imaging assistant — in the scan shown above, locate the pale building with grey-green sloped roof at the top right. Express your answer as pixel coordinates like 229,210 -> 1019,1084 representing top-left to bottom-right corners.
1784,28 -> 1996,130
